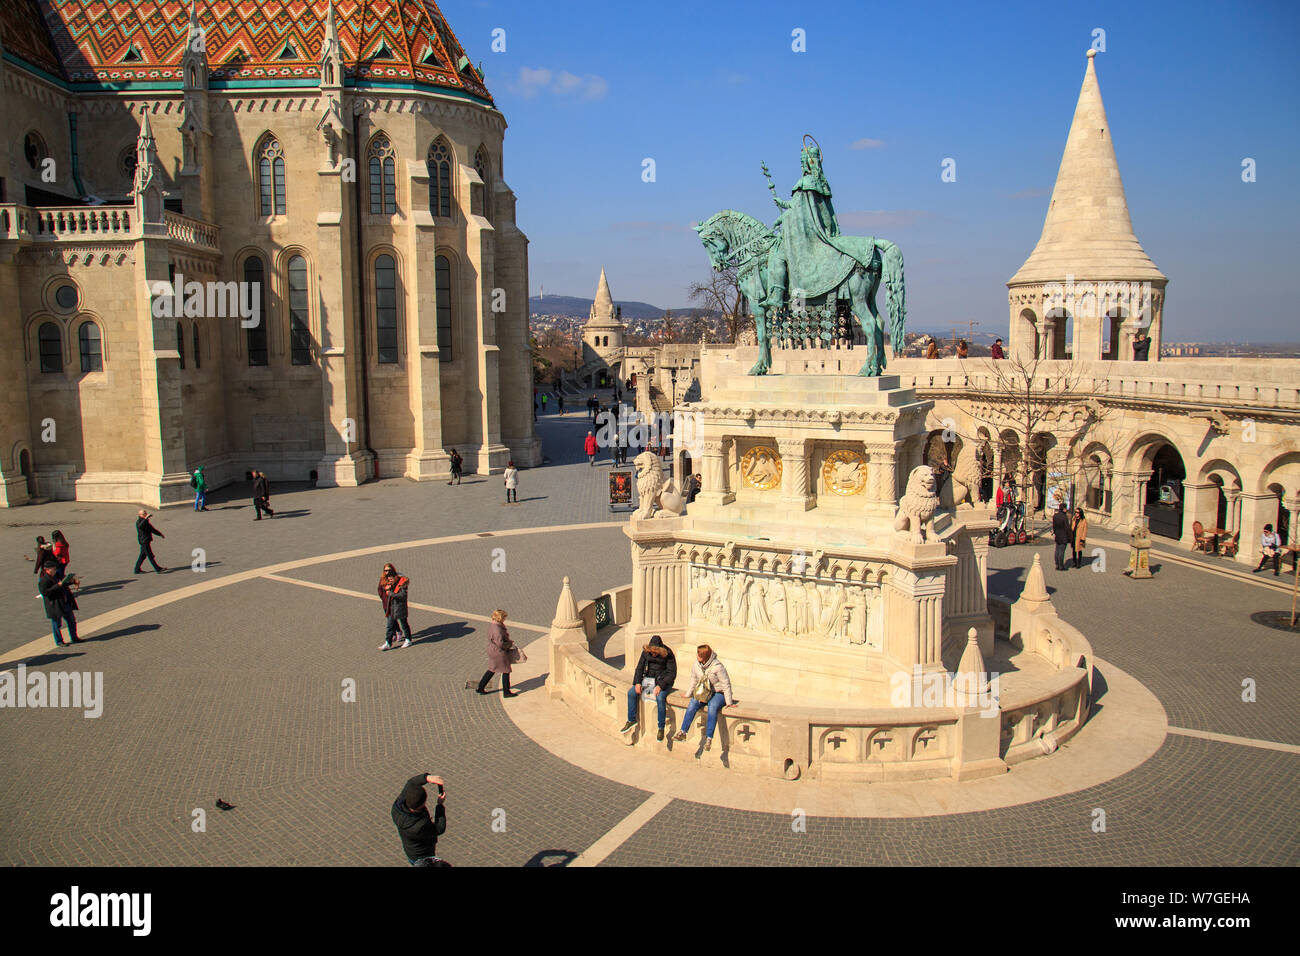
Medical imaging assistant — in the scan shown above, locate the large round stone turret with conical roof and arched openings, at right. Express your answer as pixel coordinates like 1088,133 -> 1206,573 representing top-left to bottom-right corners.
1006,49 -> 1166,362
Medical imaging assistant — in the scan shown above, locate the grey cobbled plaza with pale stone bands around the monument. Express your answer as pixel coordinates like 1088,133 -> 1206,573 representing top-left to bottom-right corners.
0,414 -> 1300,866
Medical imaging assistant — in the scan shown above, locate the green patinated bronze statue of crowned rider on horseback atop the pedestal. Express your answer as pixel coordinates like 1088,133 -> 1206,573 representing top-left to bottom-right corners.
696,137 -> 907,375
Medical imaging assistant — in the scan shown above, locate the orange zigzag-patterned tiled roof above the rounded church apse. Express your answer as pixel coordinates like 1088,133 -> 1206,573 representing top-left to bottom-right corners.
36,0 -> 491,103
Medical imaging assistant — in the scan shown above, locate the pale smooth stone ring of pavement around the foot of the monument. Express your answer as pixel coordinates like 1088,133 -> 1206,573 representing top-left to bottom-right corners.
506,636 -> 1169,817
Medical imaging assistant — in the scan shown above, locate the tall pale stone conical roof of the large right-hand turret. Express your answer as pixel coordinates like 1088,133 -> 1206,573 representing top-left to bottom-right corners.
1008,49 -> 1165,285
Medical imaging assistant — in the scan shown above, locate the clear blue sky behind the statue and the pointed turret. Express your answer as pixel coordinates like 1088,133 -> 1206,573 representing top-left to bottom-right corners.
441,0 -> 1300,341
